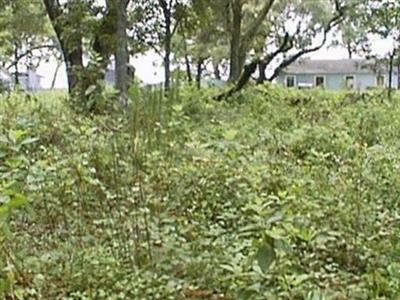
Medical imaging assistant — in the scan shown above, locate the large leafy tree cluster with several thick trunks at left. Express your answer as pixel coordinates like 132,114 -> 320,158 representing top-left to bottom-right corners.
43,0 -> 129,106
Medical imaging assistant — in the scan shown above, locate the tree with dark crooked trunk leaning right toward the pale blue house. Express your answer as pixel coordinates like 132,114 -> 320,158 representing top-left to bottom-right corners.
216,0 -> 350,100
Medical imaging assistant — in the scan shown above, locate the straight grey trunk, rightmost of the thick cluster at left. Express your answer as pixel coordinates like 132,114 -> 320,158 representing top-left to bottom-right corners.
115,0 -> 129,105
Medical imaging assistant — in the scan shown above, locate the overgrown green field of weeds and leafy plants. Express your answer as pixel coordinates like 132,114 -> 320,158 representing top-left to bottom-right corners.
0,86 -> 400,300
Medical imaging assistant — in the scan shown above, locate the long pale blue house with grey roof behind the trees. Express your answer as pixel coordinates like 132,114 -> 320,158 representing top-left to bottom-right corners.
277,59 -> 399,91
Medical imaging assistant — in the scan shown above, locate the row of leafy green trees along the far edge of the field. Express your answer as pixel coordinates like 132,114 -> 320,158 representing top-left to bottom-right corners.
0,0 -> 400,102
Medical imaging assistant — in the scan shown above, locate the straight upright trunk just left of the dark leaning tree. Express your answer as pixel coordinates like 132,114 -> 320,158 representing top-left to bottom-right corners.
228,0 -> 243,82
